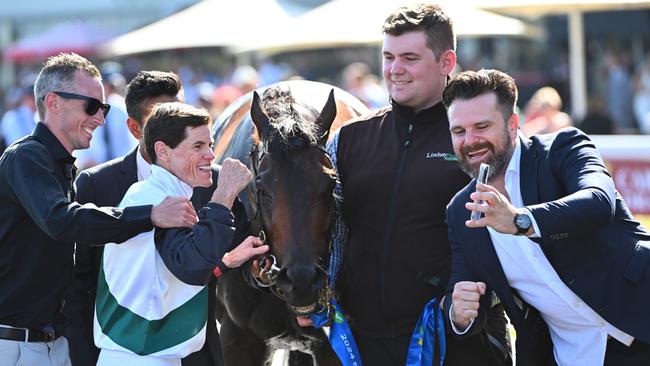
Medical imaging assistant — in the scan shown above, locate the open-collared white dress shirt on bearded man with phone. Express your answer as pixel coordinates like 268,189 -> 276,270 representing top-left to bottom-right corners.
488,140 -> 634,366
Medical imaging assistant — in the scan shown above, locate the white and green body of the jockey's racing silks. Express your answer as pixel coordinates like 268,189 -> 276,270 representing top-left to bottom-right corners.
94,165 -> 208,358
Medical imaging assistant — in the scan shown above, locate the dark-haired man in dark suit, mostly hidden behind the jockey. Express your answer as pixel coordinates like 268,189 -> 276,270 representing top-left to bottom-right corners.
63,71 -> 249,366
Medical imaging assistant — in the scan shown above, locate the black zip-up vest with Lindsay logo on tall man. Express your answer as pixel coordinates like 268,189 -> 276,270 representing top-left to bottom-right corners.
337,103 -> 469,338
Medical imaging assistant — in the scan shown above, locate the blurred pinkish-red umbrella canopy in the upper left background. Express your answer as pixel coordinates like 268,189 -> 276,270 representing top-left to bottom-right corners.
4,21 -> 116,63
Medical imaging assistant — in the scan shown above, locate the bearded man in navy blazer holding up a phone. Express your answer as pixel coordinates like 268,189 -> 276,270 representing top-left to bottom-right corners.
443,70 -> 650,365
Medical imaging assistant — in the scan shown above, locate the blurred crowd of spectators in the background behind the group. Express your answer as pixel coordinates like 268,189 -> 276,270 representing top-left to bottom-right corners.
5,48 -> 650,169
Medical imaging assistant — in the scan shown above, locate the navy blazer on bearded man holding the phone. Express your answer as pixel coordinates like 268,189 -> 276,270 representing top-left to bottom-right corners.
445,128 -> 650,365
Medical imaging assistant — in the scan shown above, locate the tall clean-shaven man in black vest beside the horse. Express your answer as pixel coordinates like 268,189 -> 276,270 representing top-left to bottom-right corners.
299,4 -> 511,366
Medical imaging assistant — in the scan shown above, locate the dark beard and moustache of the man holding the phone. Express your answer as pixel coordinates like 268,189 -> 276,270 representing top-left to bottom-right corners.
458,130 -> 514,180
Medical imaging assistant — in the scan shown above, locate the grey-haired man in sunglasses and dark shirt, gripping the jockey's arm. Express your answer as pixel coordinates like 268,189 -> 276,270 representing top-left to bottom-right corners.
0,54 -> 197,366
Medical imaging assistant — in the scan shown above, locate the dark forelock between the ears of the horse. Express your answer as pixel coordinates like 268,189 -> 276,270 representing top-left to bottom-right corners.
261,86 -> 319,153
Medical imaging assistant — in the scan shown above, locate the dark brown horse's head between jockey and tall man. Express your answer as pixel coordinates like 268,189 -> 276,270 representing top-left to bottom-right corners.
251,87 -> 336,314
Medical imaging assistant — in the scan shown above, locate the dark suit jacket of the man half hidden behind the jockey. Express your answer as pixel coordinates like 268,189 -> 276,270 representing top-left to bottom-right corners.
62,147 -> 249,366
